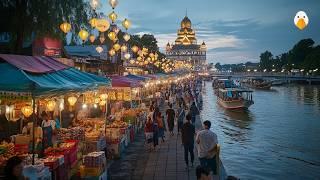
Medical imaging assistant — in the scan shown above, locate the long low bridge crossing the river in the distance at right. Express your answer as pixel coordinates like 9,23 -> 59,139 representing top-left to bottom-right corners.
210,73 -> 320,84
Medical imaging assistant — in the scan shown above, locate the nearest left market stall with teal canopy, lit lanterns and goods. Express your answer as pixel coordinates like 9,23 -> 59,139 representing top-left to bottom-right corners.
0,54 -> 110,179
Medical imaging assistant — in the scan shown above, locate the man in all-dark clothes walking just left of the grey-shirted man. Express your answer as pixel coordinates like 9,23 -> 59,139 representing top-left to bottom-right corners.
182,114 -> 195,168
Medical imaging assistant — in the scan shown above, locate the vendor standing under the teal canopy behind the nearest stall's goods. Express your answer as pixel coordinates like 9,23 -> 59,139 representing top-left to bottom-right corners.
41,111 -> 56,149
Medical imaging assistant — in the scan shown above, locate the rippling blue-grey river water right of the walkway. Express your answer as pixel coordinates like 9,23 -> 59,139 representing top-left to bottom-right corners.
201,82 -> 320,179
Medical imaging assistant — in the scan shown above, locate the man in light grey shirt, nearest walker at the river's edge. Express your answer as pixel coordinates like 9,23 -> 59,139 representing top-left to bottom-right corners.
196,121 -> 218,174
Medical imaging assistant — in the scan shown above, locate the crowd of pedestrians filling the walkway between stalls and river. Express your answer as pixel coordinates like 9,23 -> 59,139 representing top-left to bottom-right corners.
145,78 -> 218,177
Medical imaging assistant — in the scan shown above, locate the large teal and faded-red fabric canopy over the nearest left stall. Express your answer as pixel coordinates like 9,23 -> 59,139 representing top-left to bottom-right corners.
0,54 -> 111,96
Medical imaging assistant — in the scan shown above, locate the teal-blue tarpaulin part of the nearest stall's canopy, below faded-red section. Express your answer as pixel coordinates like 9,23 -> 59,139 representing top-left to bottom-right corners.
0,55 -> 111,96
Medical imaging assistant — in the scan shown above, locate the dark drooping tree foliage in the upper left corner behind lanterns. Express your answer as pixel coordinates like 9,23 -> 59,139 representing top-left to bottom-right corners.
0,0 -> 93,54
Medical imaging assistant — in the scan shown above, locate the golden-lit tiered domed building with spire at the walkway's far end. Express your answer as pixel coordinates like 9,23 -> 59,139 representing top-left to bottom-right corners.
166,16 -> 207,65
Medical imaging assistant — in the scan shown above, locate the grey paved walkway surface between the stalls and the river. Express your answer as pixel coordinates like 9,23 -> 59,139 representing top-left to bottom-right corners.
109,105 -> 205,180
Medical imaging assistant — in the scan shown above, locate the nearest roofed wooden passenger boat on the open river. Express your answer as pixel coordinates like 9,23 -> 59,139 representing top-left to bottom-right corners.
216,88 -> 254,109
